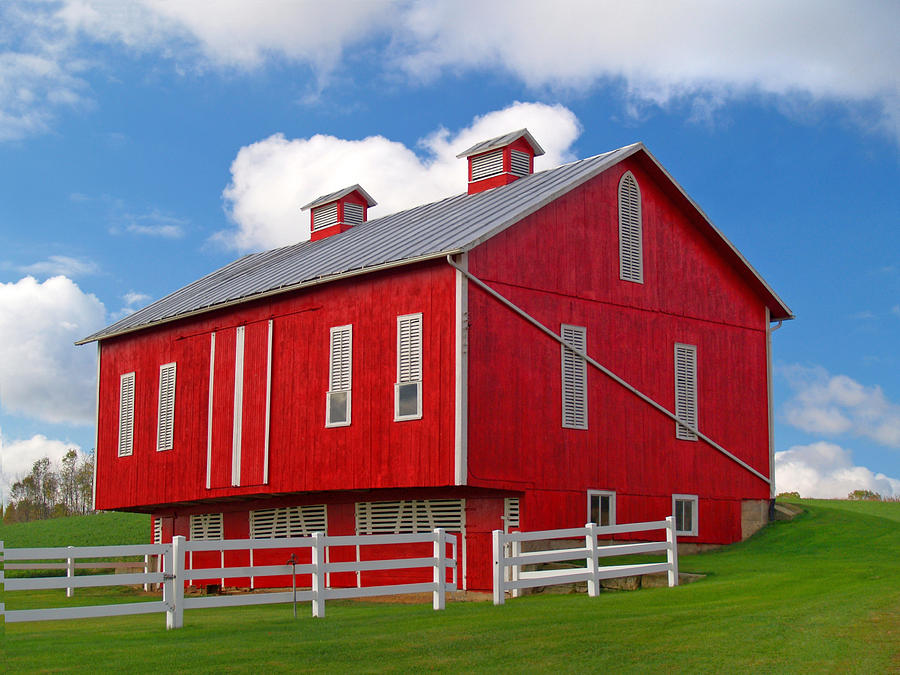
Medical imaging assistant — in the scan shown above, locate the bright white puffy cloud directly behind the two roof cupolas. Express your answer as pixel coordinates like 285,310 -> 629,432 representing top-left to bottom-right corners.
217,102 -> 580,250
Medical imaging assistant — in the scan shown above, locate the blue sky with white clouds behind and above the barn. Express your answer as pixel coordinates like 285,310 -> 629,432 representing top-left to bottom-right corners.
0,0 -> 900,496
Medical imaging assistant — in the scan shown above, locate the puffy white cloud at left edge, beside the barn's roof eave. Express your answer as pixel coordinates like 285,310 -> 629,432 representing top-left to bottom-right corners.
0,276 -> 105,424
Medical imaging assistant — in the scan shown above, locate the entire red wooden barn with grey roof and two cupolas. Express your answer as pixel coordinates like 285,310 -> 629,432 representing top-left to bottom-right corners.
82,130 -> 792,589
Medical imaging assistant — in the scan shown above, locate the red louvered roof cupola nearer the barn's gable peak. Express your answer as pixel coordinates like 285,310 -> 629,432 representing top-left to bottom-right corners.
457,129 -> 544,194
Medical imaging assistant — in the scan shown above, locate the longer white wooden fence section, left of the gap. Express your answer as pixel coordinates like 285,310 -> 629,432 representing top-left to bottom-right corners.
0,528 -> 457,628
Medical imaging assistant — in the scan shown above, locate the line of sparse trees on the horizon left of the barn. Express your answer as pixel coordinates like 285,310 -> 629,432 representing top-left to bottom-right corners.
3,448 -> 94,523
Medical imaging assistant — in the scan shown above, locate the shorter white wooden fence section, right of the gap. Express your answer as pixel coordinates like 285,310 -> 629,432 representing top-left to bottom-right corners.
493,516 -> 678,605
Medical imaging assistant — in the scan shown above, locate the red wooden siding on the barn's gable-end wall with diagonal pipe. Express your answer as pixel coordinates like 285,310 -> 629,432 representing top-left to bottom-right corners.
468,154 -> 769,542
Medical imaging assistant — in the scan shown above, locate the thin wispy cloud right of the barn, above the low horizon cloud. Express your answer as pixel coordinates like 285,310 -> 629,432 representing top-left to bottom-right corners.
780,366 -> 900,448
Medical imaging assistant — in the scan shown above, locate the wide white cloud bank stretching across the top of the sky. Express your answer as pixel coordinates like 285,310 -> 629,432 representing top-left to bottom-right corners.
0,0 -> 900,140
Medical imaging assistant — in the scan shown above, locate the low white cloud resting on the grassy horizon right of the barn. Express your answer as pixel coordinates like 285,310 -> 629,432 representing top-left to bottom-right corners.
775,441 -> 900,499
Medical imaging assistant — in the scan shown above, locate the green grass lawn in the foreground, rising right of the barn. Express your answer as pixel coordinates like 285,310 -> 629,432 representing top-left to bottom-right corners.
4,501 -> 900,673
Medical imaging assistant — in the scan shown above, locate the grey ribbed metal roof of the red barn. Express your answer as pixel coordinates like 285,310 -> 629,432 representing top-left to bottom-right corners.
76,143 -> 792,344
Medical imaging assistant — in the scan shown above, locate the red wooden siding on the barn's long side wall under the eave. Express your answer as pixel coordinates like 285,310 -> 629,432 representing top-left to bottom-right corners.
97,261 -> 455,509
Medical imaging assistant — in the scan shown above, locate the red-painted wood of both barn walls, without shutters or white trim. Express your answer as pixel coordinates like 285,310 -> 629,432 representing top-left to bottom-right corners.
97,149 -> 783,588
